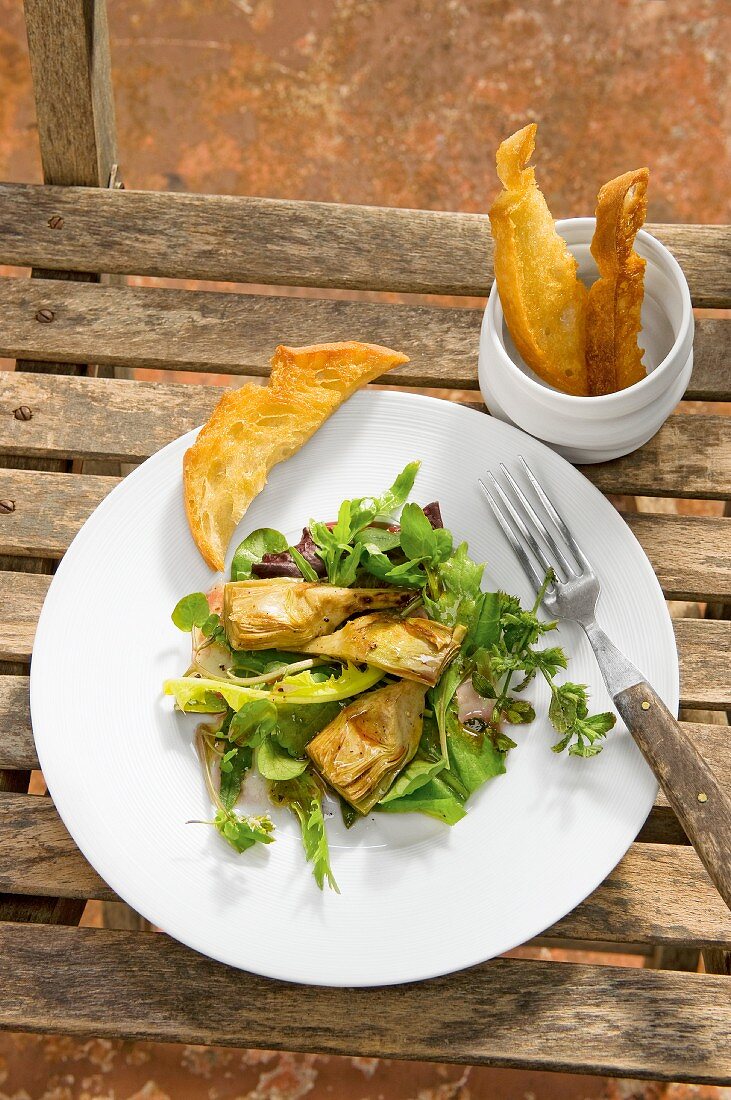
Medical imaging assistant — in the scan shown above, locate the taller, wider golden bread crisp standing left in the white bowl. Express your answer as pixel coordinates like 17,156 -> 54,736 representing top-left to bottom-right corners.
490,123 -> 587,395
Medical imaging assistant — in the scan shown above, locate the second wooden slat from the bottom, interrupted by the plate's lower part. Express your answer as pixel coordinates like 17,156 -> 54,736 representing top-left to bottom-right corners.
0,794 -> 731,949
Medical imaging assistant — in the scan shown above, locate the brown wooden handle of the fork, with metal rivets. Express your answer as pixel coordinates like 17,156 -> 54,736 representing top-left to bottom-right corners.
614,681 -> 731,909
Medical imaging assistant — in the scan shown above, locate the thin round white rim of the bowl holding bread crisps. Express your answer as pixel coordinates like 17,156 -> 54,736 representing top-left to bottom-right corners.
485,218 -> 694,409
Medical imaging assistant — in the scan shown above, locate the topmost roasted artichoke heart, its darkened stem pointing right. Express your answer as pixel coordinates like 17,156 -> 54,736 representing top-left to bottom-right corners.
223,576 -> 413,649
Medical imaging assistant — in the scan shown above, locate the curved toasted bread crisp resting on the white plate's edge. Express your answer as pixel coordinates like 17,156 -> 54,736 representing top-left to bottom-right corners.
182,342 -> 409,570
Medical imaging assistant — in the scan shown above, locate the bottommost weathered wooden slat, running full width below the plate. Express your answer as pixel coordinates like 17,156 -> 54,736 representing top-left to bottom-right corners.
0,924 -> 731,1084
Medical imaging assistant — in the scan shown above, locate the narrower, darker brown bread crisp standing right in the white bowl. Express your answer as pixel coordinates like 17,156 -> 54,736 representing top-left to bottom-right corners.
586,168 -> 650,394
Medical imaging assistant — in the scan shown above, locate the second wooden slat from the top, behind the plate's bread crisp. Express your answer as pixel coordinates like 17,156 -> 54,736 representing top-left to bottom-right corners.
0,278 -> 731,400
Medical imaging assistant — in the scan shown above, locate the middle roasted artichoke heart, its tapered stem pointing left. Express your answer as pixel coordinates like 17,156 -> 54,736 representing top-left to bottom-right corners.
299,614 -> 465,688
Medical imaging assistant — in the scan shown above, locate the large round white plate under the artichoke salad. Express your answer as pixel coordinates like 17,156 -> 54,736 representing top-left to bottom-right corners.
31,392 -> 678,986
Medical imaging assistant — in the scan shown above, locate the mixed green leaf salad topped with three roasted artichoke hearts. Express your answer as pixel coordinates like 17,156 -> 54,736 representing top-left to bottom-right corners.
164,462 -> 614,890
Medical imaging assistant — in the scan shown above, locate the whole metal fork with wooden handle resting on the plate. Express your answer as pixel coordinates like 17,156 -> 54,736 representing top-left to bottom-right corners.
479,455 -> 731,909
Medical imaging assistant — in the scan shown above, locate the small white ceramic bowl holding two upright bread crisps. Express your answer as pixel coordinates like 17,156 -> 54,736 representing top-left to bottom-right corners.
479,218 -> 694,462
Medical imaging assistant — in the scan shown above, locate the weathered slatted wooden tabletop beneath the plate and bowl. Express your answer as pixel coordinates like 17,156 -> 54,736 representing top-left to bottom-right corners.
0,185 -> 731,1082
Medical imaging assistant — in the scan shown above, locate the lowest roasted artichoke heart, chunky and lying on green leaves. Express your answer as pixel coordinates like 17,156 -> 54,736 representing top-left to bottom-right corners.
307,680 -> 427,814
